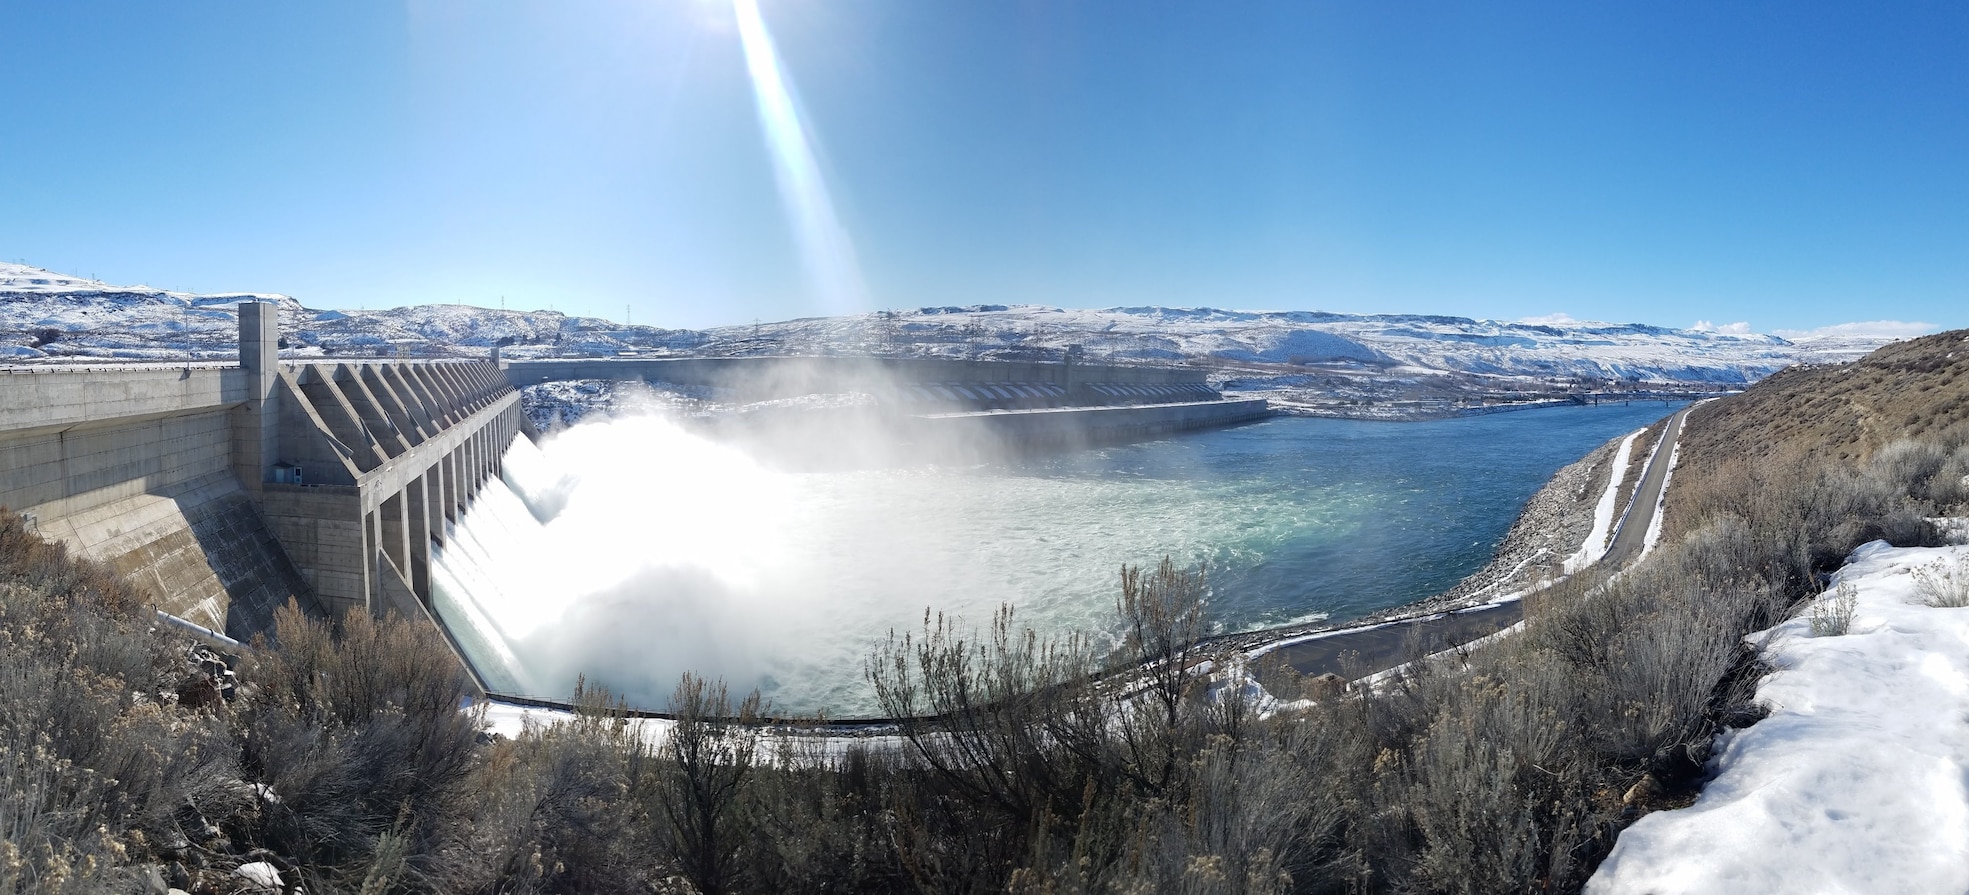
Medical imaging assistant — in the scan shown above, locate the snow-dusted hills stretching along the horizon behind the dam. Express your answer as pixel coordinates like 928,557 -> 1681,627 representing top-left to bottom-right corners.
0,264 -> 1890,417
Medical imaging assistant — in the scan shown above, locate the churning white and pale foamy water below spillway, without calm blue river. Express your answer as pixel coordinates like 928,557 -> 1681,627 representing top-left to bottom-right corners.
433,415 -> 1284,710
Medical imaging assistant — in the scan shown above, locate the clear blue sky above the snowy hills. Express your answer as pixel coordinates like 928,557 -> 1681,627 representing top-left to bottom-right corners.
0,0 -> 1969,332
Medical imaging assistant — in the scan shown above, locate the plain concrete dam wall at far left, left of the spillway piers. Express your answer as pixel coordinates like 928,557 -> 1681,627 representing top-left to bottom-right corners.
0,368 -> 309,637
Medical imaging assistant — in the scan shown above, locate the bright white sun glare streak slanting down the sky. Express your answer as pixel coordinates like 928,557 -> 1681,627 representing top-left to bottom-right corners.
732,0 -> 866,313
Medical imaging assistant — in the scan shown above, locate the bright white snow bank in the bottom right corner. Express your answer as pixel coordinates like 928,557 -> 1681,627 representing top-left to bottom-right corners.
1585,541 -> 1969,895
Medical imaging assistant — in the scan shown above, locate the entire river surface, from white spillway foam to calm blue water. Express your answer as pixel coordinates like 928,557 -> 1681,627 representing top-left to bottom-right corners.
431,403 -> 1672,718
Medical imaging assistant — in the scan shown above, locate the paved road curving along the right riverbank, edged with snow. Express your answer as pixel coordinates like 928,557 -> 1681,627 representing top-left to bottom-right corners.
1266,407 -> 1693,679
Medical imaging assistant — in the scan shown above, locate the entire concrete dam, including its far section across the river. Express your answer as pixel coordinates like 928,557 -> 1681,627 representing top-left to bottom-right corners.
0,303 -> 1266,680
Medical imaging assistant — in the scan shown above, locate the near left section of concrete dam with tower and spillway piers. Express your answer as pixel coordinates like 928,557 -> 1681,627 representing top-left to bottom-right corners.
0,303 -> 526,639
